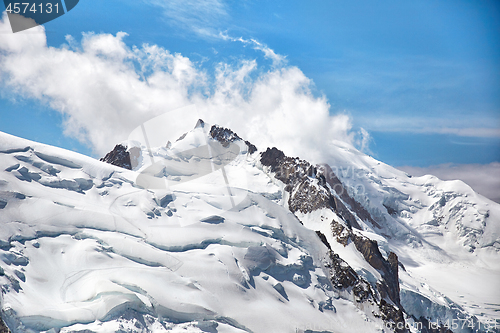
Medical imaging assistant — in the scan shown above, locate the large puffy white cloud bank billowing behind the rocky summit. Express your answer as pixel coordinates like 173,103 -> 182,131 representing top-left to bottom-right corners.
0,15 -> 367,162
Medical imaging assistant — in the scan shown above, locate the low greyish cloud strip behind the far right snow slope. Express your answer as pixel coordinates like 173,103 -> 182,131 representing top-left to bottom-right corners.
398,162 -> 500,203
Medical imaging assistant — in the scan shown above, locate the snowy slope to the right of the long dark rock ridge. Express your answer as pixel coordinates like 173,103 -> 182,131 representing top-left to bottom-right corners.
318,143 -> 500,331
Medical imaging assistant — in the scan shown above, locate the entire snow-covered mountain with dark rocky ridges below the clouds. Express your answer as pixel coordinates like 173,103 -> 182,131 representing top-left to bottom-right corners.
0,121 -> 500,333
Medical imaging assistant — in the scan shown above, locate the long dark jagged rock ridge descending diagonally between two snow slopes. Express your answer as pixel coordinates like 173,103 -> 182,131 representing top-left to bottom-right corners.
260,148 -> 404,332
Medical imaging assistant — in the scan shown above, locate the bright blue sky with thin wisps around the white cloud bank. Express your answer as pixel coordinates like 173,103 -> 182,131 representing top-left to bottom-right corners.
0,0 -> 500,167
